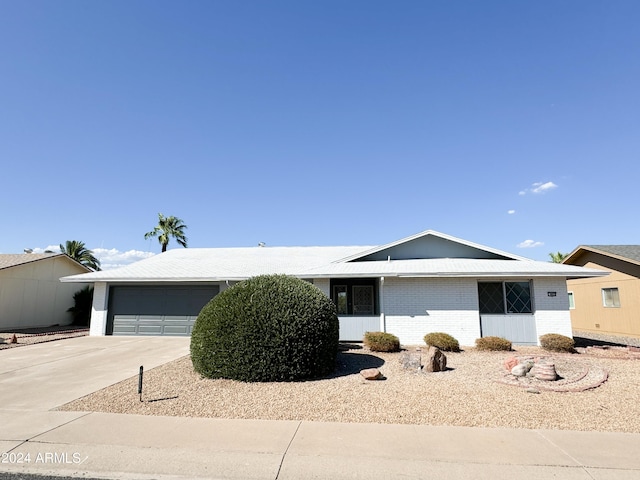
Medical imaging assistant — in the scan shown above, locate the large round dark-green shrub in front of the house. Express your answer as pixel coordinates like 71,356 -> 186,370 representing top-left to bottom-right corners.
191,275 -> 339,382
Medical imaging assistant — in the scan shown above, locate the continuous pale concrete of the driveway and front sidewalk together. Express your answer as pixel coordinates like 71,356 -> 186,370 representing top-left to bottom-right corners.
0,337 -> 640,480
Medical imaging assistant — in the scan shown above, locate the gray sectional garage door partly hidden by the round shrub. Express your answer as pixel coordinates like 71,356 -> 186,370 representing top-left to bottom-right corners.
107,285 -> 220,336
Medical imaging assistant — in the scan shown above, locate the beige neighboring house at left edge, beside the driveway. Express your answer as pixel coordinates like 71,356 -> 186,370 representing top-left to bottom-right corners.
0,253 -> 91,331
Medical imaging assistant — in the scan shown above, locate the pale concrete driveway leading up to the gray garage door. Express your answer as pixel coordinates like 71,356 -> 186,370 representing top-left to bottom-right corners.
0,336 -> 189,411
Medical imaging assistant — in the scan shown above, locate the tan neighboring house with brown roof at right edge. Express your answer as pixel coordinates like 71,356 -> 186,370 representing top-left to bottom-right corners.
562,245 -> 640,338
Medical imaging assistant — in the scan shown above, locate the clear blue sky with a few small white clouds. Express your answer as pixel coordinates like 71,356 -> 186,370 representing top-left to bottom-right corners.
0,0 -> 640,266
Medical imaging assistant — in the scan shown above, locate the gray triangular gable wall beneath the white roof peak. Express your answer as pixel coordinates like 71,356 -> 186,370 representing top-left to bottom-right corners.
353,235 -> 512,262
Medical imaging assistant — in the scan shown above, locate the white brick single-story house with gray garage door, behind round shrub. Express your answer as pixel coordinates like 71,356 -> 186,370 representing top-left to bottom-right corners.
61,230 -> 605,345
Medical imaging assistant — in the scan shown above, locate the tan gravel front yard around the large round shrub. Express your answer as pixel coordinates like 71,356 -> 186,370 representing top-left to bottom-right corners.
61,347 -> 640,433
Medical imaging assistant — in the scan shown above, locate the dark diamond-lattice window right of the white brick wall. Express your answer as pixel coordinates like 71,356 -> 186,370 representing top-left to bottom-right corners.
478,282 -> 533,314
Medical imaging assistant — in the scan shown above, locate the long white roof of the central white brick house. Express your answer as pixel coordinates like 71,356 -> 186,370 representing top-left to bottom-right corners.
61,230 -> 608,283
